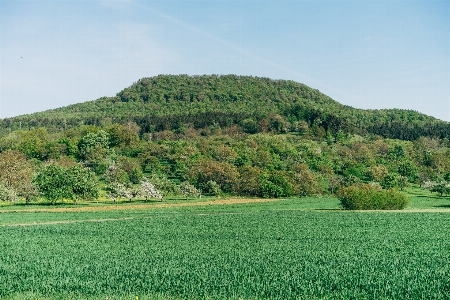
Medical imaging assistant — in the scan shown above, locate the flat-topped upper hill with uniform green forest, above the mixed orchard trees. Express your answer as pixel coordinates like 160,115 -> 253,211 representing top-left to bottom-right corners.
0,75 -> 450,140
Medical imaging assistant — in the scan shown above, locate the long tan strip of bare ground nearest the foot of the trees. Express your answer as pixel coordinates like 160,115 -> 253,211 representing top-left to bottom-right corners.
0,198 -> 280,213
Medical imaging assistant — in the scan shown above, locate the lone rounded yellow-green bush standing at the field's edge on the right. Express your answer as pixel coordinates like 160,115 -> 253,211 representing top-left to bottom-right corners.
338,184 -> 408,210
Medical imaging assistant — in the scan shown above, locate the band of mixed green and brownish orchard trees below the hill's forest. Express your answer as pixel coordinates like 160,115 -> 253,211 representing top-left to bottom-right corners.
0,115 -> 450,203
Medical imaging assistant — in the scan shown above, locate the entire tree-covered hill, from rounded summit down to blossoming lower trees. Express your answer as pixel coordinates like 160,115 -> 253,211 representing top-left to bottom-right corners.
0,75 -> 450,202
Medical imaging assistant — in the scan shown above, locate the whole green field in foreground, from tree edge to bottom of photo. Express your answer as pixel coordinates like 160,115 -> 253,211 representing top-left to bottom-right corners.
0,196 -> 450,300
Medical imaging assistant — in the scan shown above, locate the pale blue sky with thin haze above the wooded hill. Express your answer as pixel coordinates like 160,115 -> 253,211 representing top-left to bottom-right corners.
0,0 -> 450,121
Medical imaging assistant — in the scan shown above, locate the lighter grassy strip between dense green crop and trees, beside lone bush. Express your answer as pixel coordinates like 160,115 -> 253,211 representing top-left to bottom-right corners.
0,188 -> 450,226
